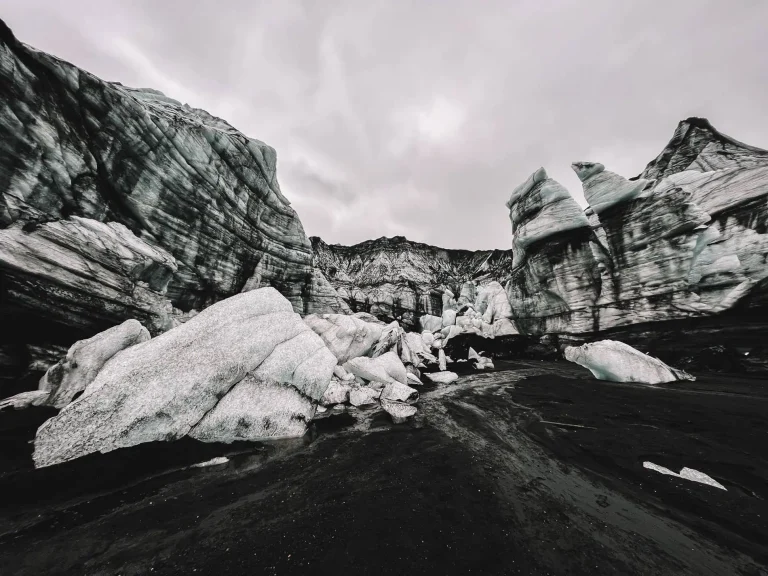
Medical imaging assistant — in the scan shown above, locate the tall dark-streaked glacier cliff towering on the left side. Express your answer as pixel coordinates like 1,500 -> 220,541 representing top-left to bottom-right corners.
0,22 -> 344,388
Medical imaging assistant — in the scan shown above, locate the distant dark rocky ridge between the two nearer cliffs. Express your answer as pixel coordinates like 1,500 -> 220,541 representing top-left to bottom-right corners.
310,236 -> 512,328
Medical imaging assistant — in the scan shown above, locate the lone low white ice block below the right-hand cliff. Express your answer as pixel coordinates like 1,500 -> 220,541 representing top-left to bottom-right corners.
565,340 -> 695,384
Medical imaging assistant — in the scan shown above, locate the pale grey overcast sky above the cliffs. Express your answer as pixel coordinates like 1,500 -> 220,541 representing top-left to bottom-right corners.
0,0 -> 768,249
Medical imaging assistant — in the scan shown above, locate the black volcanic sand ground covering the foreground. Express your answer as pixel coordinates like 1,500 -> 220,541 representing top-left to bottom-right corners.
0,361 -> 768,576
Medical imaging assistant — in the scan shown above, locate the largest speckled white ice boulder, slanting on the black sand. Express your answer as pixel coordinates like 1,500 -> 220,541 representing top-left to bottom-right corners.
33,288 -> 336,467
